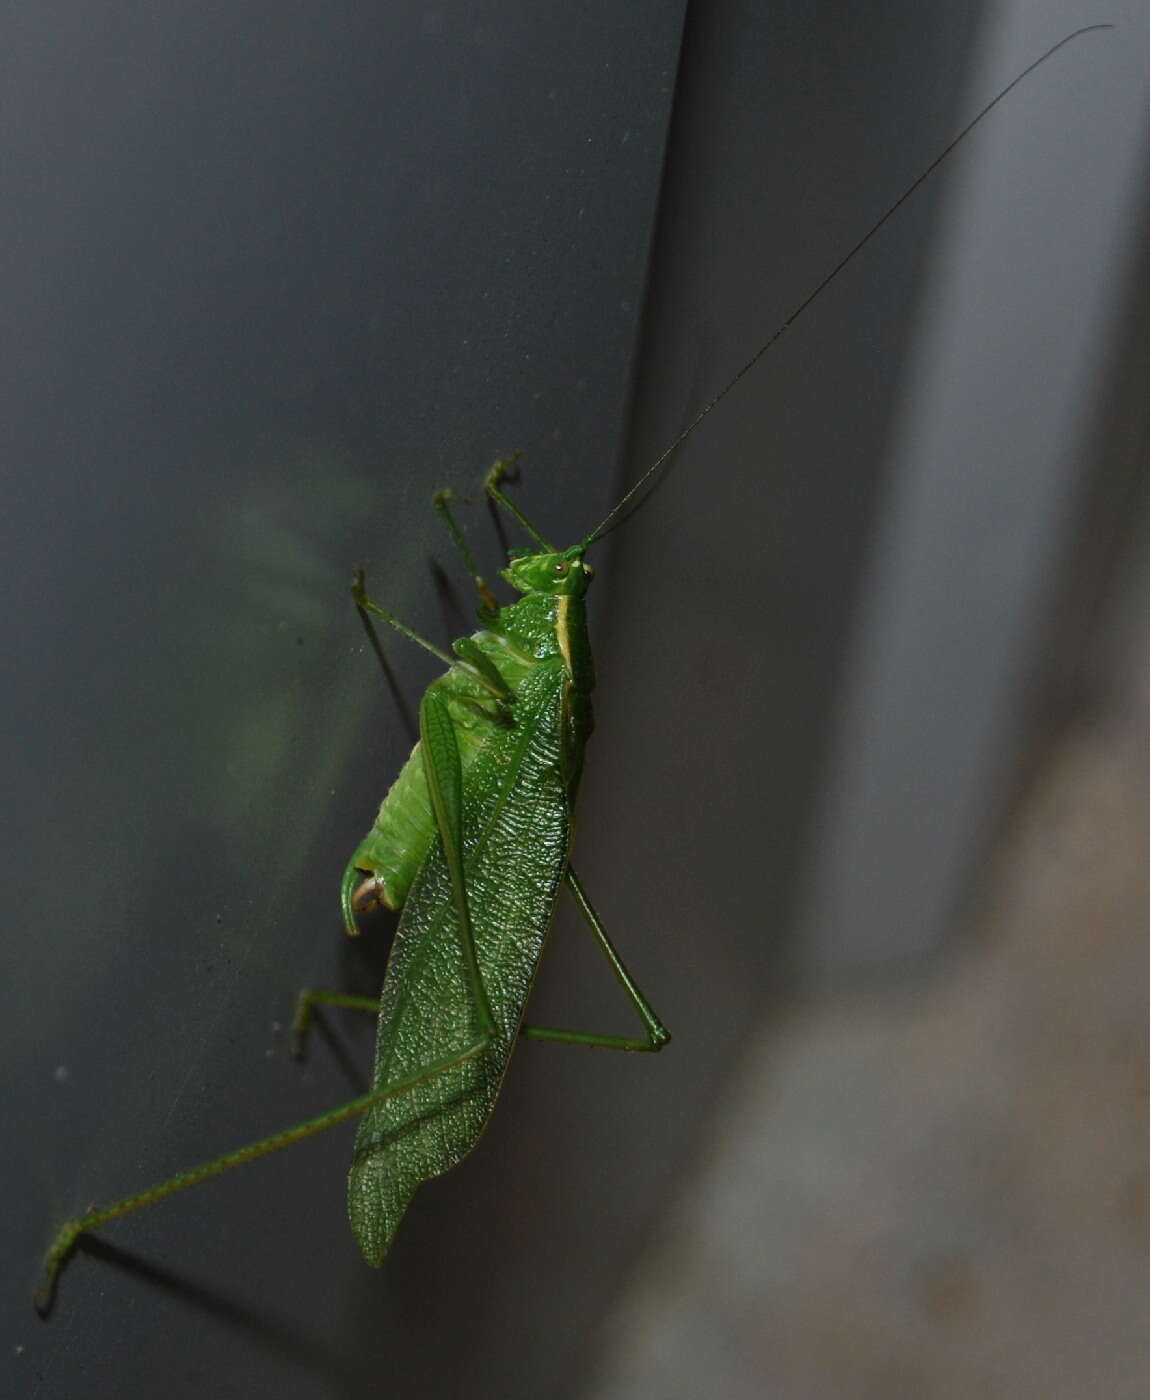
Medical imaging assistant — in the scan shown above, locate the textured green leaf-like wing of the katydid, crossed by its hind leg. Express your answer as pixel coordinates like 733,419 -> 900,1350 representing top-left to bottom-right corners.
349,657 -> 570,1264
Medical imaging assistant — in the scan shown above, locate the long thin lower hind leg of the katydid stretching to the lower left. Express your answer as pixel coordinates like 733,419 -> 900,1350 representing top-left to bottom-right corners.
35,1035 -> 490,1316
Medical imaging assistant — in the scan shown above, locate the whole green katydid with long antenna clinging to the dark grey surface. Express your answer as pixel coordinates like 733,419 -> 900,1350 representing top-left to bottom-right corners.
36,25 -> 1108,1312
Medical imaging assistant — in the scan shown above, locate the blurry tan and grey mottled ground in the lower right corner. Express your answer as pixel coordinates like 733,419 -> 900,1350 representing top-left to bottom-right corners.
586,637 -> 1150,1400
